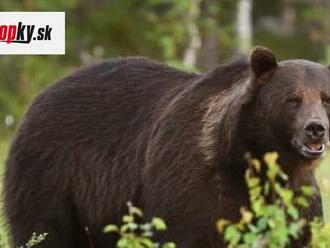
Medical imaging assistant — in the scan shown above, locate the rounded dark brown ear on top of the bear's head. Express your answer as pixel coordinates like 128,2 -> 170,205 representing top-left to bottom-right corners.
250,46 -> 277,78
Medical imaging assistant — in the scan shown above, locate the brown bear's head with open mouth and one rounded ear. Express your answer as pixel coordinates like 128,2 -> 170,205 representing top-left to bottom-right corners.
242,47 -> 330,168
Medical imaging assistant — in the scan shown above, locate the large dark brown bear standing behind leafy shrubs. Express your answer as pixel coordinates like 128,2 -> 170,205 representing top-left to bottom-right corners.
4,47 -> 330,248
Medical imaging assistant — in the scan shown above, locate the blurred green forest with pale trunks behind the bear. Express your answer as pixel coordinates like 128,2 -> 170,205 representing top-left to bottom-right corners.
0,0 -> 330,221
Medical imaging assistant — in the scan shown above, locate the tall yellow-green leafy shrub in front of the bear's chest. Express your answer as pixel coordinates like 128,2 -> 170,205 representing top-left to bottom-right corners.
218,153 -> 314,248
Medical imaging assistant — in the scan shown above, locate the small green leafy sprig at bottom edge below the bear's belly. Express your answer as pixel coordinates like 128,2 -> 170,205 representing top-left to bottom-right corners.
104,202 -> 175,248
